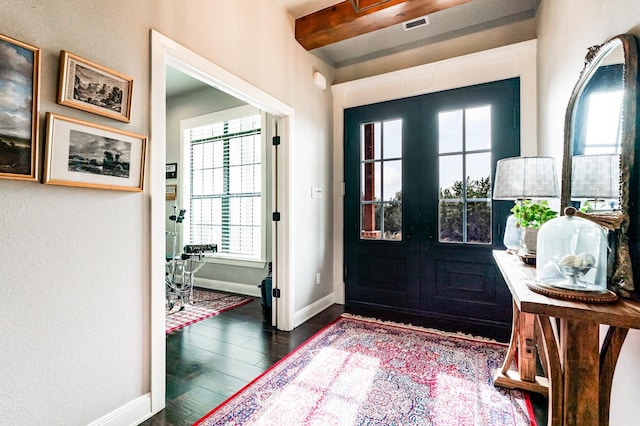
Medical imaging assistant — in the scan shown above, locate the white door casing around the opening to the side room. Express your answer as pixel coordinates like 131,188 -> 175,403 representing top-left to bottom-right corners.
152,30 -> 293,413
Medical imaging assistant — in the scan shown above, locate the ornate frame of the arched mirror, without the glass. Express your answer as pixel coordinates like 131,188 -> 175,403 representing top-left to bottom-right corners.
561,34 -> 638,297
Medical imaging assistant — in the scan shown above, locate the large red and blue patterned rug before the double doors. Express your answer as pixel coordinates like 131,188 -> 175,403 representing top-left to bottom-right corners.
196,316 -> 535,426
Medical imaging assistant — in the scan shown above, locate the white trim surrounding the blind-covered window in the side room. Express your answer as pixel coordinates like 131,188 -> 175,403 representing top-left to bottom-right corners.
180,105 -> 269,268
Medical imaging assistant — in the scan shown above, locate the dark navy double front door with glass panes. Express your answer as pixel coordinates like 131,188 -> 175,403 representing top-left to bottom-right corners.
344,79 -> 520,334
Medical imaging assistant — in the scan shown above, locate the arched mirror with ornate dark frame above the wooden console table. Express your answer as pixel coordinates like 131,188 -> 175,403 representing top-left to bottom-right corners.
561,34 -> 638,297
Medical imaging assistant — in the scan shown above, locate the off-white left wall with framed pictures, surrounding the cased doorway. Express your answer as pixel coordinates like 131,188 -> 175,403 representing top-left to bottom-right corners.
0,0 -> 332,425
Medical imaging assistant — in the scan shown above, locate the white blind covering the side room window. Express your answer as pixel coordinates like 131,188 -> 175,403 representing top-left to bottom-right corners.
184,109 -> 262,260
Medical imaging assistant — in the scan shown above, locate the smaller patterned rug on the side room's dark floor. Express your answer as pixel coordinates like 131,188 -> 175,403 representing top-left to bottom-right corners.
165,287 -> 253,333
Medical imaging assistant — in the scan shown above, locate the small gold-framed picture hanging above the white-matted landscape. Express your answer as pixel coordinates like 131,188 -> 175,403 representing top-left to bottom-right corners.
58,50 -> 133,123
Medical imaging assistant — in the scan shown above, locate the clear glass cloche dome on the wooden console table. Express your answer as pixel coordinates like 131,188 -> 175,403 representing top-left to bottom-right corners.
536,208 -> 607,293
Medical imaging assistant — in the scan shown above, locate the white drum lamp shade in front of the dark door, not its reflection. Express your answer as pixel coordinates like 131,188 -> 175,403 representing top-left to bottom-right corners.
493,157 -> 560,200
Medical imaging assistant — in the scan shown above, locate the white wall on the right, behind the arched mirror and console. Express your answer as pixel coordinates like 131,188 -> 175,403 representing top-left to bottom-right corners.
538,0 -> 640,426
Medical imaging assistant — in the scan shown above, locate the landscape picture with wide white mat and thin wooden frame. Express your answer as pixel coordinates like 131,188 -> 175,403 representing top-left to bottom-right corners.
43,112 -> 147,191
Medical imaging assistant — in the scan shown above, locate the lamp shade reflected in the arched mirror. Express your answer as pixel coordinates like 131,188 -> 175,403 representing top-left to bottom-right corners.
571,154 -> 620,199
